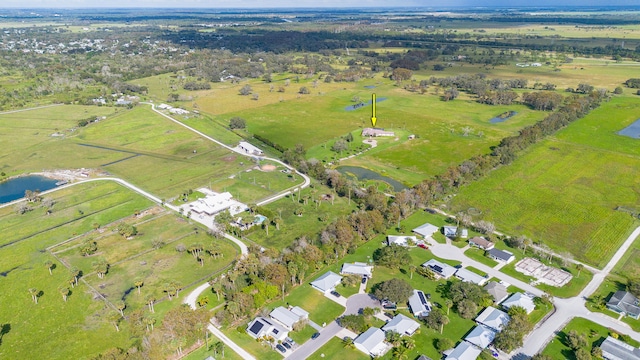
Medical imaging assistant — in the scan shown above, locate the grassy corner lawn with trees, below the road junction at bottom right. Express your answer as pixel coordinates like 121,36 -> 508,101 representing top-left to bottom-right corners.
542,318 -> 638,360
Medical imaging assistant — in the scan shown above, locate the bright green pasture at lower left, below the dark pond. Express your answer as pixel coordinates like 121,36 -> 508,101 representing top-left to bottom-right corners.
0,182 -> 151,359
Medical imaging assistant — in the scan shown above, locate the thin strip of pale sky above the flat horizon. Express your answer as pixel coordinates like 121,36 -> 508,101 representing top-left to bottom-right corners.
0,0 -> 640,8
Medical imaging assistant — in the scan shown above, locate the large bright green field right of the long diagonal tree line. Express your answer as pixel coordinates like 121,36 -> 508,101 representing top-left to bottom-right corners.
450,95 -> 640,266
